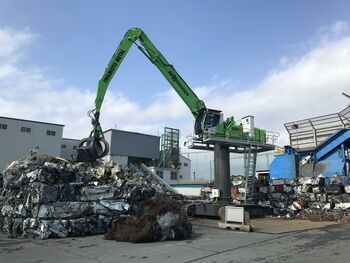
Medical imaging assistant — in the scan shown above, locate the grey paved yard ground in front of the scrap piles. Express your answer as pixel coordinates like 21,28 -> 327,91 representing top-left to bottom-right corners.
0,218 -> 350,263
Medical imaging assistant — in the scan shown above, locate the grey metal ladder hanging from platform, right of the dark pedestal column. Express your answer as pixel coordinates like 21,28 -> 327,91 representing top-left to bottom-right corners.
244,145 -> 257,204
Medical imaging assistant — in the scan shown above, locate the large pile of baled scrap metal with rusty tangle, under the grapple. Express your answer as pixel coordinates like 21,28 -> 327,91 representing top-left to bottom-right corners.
0,156 -> 192,242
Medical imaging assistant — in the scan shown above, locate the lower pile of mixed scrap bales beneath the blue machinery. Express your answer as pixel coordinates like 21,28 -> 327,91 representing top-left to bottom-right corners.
259,176 -> 350,221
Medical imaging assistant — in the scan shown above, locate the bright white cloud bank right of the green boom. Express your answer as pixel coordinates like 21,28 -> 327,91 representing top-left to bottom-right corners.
200,22 -> 350,144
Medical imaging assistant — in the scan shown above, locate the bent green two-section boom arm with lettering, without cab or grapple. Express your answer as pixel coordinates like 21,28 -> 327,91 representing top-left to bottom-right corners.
95,28 -> 206,118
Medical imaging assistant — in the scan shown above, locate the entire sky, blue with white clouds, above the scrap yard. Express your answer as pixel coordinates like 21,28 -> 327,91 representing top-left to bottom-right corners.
0,0 -> 350,144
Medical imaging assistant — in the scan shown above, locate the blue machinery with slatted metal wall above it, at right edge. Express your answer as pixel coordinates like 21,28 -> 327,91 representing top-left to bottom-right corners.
270,106 -> 350,179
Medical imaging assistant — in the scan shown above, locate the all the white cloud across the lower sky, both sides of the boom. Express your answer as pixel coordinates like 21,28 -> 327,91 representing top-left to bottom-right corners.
0,21 -> 350,150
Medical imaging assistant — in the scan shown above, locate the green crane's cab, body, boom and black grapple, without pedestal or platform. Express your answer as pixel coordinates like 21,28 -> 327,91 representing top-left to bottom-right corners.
74,28 -> 266,162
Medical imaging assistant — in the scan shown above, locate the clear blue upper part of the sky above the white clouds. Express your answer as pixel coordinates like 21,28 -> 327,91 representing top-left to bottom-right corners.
0,0 -> 350,93
